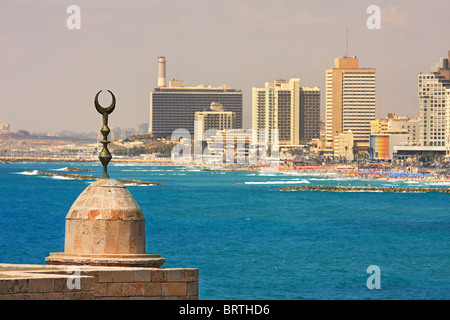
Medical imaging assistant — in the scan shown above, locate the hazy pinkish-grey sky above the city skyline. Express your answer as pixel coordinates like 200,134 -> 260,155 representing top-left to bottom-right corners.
0,0 -> 450,132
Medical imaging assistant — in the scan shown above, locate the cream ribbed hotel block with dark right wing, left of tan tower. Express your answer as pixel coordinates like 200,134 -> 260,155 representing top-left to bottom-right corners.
252,78 -> 320,146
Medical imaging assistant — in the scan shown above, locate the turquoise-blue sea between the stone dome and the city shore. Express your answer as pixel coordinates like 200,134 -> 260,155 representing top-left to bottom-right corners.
0,163 -> 450,300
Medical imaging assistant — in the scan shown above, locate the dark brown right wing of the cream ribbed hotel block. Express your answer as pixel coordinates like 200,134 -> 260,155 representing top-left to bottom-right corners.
300,87 -> 320,144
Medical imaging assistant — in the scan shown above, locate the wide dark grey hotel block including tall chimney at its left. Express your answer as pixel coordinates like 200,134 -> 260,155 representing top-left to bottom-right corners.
148,57 -> 242,137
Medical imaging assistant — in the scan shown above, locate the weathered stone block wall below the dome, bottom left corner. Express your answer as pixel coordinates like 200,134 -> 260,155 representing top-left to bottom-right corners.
0,264 -> 199,300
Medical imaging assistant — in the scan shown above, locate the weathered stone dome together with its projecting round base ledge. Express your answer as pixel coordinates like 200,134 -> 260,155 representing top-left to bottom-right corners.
46,178 -> 165,267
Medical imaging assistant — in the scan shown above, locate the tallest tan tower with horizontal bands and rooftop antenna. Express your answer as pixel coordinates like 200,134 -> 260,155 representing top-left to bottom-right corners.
325,57 -> 376,147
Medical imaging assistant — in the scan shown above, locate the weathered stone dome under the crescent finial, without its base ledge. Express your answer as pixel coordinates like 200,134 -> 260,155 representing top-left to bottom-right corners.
64,179 -> 145,254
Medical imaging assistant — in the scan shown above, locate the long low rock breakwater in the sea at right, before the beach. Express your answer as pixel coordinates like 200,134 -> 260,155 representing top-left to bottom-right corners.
276,186 -> 450,193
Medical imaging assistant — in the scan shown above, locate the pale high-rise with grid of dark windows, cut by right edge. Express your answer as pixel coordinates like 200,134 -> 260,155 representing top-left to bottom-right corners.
418,52 -> 450,147
